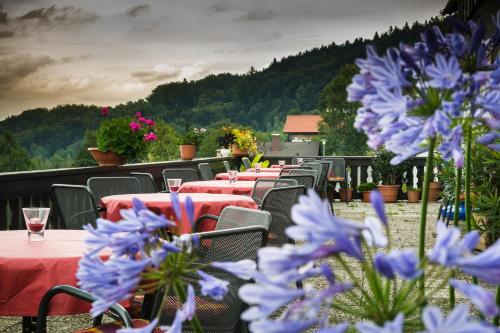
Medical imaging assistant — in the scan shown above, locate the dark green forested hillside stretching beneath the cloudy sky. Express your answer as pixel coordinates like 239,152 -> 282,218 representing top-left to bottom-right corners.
0,17 -> 446,156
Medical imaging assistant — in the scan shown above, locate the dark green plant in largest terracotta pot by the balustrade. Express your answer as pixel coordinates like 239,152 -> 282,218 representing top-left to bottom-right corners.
372,147 -> 409,202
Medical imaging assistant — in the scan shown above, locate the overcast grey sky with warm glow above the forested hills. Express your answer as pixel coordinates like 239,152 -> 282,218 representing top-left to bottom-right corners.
0,0 -> 446,119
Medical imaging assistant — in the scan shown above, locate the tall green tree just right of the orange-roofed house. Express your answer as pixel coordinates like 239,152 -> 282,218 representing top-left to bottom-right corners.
320,64 -> 368,155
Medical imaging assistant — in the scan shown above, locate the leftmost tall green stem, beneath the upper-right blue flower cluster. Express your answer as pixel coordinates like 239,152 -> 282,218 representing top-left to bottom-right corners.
418,138 -> 436,298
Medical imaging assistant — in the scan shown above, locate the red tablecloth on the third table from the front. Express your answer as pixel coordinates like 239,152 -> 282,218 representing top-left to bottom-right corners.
179,180 -> 255,195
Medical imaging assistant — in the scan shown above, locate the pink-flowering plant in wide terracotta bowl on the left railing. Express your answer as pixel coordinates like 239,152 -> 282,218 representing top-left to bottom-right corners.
88,108 -> 157,166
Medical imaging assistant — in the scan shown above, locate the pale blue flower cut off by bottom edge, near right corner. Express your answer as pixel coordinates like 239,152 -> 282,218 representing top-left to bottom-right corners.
422,304 -> 496,333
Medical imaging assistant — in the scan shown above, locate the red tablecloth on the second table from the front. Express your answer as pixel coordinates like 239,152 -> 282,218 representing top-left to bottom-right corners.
102,193 -> 257,233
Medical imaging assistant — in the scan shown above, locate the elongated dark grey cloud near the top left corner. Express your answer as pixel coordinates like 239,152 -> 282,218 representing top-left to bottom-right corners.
17,5 -> 98,26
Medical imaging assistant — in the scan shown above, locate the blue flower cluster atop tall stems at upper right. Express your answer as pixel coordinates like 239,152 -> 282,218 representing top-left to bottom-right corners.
347,12 -> 500,167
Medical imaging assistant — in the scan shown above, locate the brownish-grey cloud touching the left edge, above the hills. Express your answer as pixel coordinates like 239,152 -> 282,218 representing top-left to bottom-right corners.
0,54 -> 55,89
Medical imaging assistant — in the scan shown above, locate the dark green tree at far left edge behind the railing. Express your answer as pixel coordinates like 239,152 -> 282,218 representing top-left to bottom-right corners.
0,131 -> 32,172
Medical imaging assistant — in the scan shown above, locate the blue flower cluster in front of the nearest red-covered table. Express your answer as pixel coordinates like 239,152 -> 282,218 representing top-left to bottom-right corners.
76,193 -> 240,333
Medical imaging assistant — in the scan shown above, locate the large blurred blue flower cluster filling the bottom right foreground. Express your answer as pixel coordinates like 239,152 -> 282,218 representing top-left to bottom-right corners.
234,191 -> 500,333
